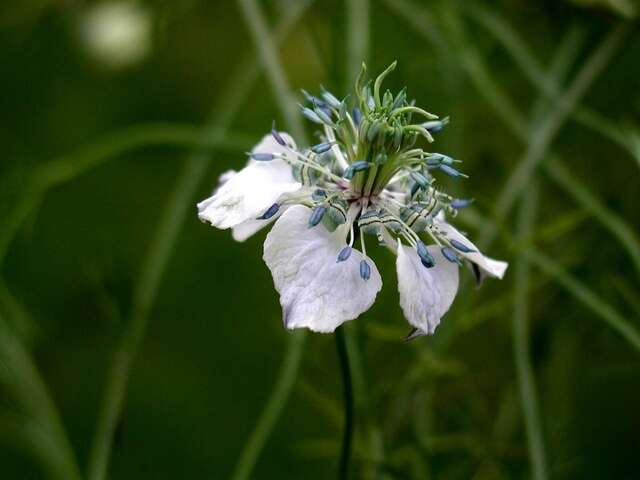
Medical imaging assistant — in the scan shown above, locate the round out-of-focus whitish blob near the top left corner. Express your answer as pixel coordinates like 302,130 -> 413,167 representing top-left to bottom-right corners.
80,1 -> 152,69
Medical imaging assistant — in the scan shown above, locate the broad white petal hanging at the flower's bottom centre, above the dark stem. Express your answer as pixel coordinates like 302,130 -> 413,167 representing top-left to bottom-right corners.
263,205 -> 382,332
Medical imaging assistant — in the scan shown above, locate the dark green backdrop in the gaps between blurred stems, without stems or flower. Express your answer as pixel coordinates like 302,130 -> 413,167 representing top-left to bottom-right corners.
0,0 -> 640,479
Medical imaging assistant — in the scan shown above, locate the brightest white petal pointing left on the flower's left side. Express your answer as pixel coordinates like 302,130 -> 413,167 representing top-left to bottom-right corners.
198,134 -> 301,228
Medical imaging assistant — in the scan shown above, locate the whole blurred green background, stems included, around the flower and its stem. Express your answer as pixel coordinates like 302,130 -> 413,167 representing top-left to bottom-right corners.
0,0 -> 640,480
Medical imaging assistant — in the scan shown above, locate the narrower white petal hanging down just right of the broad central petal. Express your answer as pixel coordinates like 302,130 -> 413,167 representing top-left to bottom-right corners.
396,244 -> 458,334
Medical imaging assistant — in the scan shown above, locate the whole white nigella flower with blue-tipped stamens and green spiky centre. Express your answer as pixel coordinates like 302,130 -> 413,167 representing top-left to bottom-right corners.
198,63 -> 507,335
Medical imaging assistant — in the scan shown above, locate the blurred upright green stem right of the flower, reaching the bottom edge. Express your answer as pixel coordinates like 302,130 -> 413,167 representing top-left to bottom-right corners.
512,183 -> 548,480
